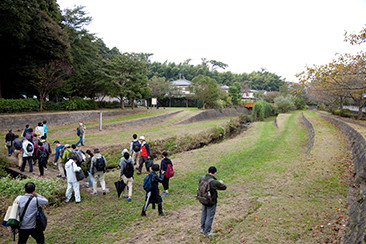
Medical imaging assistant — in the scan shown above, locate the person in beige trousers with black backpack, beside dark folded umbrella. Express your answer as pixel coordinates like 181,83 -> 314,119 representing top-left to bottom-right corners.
119,149 -> 134,202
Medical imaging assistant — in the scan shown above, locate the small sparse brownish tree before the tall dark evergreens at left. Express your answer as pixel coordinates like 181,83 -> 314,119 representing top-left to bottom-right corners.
31,60 -> 71,112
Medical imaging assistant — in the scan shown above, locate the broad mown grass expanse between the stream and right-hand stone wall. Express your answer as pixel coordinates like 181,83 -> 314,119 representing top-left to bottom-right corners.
2,112 -> 347,243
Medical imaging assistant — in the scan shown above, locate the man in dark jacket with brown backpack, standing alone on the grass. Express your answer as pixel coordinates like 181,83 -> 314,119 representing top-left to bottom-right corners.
197,166 -> 226,236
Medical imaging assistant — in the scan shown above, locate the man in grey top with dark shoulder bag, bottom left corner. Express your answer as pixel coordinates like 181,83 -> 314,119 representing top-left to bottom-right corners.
16,182 -> 48,244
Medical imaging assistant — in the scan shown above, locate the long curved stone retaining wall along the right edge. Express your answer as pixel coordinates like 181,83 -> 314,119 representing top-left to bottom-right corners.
320,114 -> 366,244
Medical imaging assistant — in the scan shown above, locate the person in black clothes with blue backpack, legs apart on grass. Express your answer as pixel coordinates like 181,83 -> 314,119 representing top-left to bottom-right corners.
141,164 -> 166,216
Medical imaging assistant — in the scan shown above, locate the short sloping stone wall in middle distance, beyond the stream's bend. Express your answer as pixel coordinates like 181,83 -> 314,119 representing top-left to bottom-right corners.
179,108 -> 249,124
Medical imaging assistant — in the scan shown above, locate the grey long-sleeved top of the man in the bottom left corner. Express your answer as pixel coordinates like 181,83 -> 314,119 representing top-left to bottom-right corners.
18,194 -> 48,230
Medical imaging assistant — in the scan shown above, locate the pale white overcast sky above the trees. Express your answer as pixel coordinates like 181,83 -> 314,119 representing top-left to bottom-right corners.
57,0 -> 366,82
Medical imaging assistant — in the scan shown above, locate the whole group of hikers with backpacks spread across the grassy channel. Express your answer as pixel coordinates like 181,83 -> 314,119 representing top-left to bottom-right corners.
6,121 -> 226,243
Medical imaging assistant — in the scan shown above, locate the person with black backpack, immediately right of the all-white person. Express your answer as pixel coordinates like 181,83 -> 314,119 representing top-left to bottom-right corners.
90,148 -> 107,195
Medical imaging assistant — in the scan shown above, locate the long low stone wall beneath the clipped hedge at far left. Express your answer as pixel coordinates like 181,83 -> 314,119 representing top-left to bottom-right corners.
0,110 -> 141,131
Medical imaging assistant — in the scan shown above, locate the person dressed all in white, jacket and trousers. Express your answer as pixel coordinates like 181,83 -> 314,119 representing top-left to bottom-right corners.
65,156 -> 82,203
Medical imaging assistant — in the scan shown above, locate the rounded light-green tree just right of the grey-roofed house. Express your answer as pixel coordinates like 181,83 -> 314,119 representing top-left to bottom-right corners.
189,75 -> 220,109
